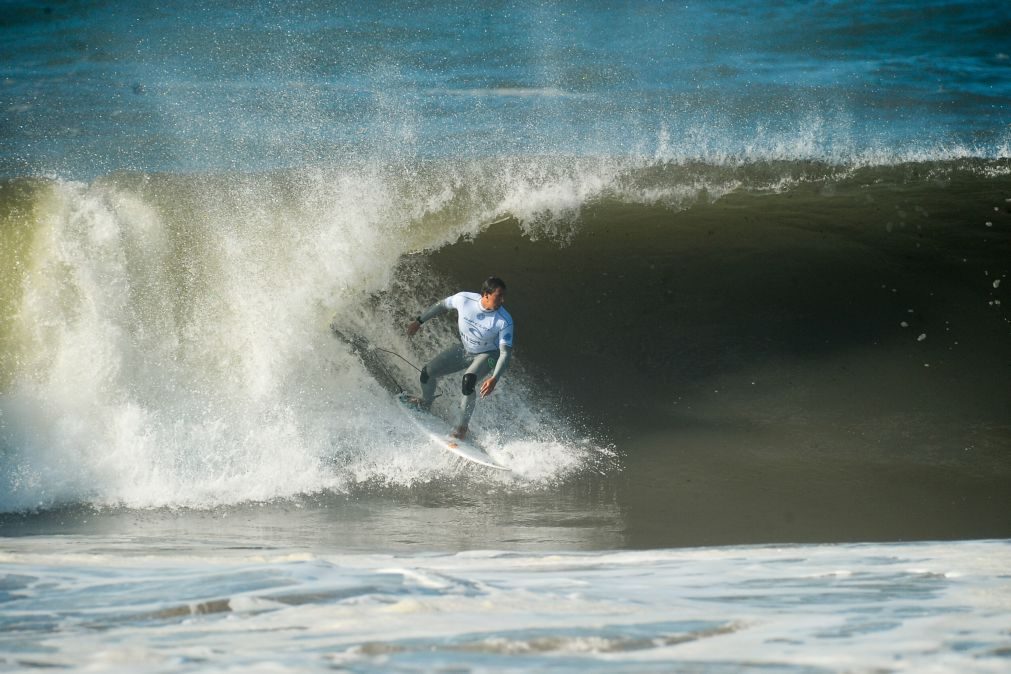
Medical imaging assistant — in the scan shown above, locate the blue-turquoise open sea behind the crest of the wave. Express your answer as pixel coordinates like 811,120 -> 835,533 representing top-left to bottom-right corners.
0,1 -> 1011,178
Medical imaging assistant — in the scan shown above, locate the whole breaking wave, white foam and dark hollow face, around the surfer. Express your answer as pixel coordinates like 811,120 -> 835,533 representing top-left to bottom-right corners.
0,158 -> 1011,525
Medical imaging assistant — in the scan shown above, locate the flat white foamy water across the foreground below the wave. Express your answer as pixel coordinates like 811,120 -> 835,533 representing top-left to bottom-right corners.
0,537 -> 1011,672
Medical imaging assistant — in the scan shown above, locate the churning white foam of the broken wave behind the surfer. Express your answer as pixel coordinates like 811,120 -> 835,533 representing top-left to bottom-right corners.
0,167 -> 626,510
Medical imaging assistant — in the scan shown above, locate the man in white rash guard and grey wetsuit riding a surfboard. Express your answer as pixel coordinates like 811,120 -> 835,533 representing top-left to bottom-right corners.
407,276 -> 513,440
